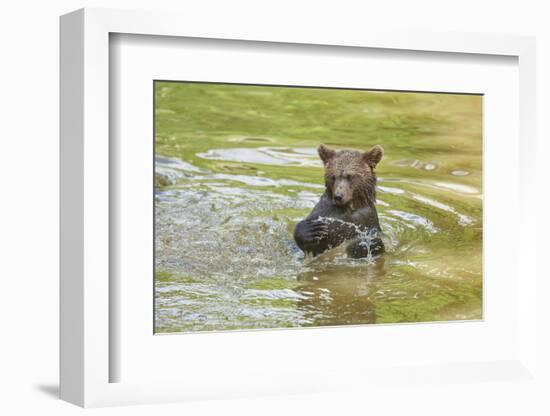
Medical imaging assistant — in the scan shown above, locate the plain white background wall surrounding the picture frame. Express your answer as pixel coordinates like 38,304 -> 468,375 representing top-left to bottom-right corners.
0,0 -> 550,415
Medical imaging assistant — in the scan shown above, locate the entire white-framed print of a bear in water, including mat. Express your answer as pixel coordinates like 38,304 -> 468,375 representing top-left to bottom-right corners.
61,9 -> 538,406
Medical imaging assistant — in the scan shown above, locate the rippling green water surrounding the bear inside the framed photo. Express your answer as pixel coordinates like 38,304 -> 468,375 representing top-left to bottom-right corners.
155,82 -> 482,333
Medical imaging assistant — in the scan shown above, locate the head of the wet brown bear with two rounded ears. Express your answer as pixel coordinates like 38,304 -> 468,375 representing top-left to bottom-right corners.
318,144 -> 384,208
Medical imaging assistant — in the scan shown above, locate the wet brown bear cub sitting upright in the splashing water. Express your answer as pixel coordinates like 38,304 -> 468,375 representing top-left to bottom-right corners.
294,144 -> 384,258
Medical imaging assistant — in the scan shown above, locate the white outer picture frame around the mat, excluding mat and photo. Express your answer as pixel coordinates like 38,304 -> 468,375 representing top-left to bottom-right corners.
60,9 -> 537,407
